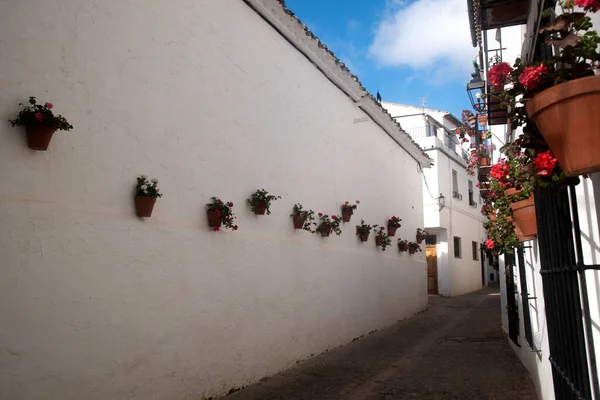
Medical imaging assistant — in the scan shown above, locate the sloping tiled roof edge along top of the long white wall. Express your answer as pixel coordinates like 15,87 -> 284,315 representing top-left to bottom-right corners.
244,0 -> 433,168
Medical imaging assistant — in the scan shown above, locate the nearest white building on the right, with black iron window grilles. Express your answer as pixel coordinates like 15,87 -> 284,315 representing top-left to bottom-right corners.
468,0 -> 600,400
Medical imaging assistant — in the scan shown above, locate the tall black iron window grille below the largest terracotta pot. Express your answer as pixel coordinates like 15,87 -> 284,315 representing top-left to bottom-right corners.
535,183 -> 600,400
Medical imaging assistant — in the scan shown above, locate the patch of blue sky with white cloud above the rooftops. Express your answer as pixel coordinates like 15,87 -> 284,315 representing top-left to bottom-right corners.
286,0 -> 477,117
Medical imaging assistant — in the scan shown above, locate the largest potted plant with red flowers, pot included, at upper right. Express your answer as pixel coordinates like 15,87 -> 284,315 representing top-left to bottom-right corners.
488,0 -> 600,176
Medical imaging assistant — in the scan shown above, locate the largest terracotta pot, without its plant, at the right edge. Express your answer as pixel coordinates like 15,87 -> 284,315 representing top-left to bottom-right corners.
525,75 -> 600,176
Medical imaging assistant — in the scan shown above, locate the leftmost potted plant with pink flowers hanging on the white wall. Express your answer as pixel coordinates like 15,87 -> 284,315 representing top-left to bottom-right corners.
9,96 -> 73,151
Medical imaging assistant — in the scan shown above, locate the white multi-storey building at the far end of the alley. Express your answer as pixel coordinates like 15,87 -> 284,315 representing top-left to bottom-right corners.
382,102 -> 488,296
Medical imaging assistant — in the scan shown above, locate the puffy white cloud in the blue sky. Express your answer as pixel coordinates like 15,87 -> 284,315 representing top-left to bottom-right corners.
369,0 -> 477,78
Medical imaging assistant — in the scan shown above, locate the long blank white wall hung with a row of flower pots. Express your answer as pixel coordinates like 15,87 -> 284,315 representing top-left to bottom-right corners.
0,0 -> 427,400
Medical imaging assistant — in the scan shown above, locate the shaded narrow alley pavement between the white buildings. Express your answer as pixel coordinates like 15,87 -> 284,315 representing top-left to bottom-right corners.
226,289 -> 536,400
